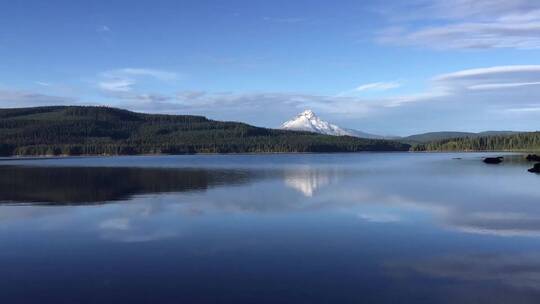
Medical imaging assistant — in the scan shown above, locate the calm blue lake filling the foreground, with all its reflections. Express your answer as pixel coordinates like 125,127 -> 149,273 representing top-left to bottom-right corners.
0,153 -> 540,304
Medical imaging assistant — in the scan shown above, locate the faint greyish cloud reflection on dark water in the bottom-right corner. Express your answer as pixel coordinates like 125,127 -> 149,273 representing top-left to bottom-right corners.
385,252 -> 540,303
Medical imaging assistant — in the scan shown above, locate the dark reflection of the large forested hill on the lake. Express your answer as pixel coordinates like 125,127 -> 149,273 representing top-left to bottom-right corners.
0,166 -> 256,205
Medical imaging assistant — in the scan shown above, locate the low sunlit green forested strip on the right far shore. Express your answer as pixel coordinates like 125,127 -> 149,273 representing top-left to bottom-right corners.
412,132 -> 540,151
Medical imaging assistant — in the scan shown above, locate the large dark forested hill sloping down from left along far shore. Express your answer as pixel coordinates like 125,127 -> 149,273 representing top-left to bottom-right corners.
0,106 -> 410,156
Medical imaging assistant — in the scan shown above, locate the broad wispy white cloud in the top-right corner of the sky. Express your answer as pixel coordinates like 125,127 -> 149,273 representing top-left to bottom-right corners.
378,0 -> 540,49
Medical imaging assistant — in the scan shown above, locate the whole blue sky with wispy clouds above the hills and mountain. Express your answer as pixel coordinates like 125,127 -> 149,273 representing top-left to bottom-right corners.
0,0 -> 540,135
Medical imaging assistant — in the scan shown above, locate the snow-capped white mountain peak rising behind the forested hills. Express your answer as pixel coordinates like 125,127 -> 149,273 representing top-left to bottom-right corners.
281,110 -> 385,139
